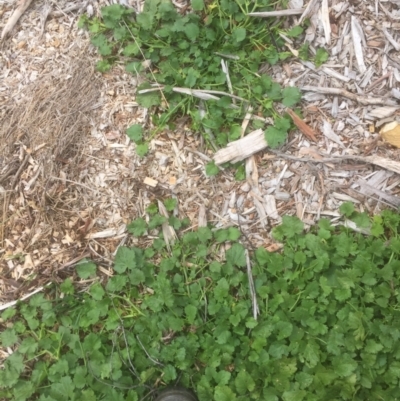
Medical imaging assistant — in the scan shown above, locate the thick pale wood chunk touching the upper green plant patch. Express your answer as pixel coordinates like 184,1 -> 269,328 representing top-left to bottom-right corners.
214,129 -> 268,164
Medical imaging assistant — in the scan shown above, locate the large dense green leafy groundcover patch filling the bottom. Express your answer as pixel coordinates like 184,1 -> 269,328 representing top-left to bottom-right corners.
0,204 -> 400,401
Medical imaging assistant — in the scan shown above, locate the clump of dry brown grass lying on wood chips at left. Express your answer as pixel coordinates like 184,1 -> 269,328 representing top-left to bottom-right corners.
0,53 -> 100,252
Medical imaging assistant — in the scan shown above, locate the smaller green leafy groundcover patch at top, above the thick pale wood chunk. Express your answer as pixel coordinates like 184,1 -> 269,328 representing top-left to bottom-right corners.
80,0 -> 312,155
